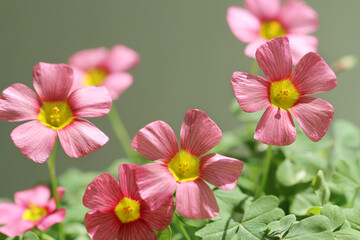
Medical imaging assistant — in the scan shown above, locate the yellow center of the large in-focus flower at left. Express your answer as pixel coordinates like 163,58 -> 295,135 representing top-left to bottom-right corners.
38,102 -> 73,129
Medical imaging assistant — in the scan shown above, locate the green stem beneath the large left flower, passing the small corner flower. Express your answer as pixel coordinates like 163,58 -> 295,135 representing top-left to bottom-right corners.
47,140 -> 65,240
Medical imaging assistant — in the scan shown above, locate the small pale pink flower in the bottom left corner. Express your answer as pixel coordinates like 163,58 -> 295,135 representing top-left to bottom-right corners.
0,185 -> 66,237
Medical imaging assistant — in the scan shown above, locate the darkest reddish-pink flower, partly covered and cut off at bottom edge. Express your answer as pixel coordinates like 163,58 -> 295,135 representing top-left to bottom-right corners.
83,164 -> 174,240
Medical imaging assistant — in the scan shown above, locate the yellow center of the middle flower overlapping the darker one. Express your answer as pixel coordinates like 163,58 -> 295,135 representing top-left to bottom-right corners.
168,150 -> 200,182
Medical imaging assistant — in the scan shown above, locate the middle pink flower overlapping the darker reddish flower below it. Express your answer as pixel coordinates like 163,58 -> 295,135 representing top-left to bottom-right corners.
131,109 -> 243,219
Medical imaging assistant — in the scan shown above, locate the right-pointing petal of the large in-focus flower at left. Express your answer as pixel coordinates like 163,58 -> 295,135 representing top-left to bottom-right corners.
68,86 -> 112,117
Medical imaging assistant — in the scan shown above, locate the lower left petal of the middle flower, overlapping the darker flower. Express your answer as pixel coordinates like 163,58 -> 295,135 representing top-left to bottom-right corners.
135,163 -> 177,209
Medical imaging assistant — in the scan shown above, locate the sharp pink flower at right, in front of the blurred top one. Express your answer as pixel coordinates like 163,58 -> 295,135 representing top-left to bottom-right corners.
231,37 -> 337,146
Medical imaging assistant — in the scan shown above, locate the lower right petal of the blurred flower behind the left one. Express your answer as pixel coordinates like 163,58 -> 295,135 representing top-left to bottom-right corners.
103,72 -> 133,100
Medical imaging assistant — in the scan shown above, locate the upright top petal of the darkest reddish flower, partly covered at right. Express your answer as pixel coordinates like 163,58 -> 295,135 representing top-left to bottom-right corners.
119,164 -> 142,201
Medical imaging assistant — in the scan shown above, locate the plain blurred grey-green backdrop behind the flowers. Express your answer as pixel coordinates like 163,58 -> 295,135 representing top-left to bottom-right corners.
0,0 -> 360,197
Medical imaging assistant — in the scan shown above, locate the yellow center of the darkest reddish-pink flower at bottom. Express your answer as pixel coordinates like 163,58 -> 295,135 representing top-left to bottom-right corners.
114,197 -> 140,223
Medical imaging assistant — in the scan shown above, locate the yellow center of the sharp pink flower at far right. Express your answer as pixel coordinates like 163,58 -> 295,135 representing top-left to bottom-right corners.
270,79 -> 300,110
